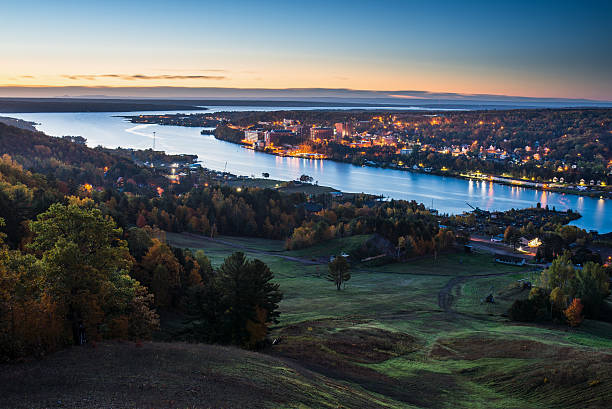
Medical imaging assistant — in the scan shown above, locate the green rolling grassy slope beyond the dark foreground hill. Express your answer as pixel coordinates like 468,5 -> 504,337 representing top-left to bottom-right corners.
163,231 -> 612,408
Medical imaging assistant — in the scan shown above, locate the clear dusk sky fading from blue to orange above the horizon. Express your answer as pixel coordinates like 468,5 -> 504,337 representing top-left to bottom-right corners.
0,0 -> 612,101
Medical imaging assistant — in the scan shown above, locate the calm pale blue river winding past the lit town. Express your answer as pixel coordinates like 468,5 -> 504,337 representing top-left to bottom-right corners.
3,106 -> 612,233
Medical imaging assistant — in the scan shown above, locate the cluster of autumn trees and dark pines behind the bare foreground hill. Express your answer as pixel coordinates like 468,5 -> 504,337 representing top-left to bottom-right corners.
0,158 -> 282,361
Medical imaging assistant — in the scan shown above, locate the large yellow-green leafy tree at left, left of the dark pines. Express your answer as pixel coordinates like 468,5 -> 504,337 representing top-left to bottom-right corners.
29,203 -> 154,339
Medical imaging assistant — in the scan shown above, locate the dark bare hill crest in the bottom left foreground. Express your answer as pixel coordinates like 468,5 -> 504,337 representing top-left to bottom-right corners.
0,342 -> 396,408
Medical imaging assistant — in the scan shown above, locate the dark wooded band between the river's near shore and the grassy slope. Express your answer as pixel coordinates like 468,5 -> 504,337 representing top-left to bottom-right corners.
0,122 -> 438,253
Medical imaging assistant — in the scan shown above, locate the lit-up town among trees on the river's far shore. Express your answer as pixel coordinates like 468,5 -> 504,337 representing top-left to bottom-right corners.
129,110 -> 612,197
